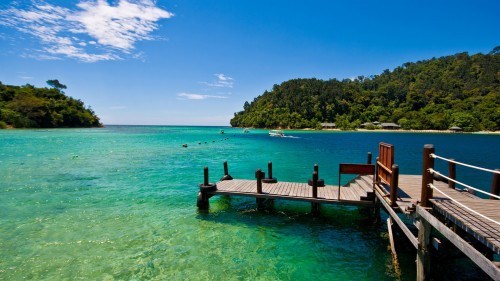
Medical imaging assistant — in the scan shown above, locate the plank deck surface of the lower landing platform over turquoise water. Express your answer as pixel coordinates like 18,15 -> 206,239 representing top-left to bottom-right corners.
209,179 -> 373,205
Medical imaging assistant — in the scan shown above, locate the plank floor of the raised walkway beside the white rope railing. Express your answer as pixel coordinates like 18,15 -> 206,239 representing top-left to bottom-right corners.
376,175 -> 500,254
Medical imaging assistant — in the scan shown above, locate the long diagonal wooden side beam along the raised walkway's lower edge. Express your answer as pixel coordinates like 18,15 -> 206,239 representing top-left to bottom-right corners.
417,206 -> 500,280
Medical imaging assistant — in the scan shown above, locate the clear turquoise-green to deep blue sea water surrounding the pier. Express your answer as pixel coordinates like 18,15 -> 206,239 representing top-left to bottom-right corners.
0,126 -> 500,280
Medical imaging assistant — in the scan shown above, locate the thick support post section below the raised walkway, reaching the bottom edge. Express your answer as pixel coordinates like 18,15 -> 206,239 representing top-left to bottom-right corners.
417,217 -> 431,281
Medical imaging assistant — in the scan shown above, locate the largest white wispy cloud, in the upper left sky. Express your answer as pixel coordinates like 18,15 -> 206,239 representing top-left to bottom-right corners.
0,0 -> 174,62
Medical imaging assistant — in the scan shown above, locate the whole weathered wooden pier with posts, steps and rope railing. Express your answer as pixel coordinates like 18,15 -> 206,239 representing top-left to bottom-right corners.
198,143 -> 500,280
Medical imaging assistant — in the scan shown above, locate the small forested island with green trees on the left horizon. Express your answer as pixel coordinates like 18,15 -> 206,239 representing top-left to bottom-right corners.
0,80 -> 102,129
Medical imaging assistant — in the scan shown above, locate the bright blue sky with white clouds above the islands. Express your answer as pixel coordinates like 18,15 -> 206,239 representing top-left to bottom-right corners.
0,0 -> 500,125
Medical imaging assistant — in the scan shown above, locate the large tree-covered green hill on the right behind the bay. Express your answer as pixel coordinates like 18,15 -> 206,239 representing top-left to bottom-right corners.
230,46 -> 500,131
